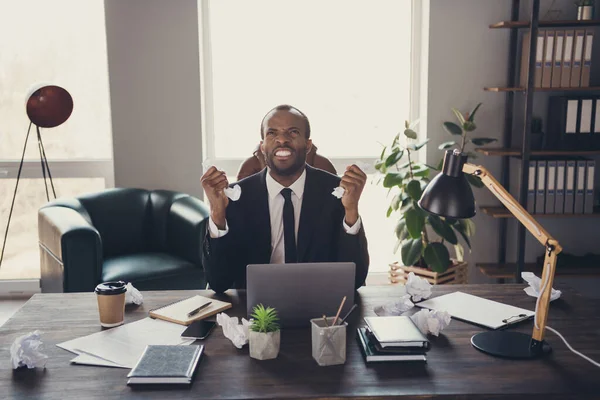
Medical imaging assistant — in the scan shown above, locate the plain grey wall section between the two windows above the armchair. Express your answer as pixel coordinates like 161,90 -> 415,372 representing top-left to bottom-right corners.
105,0 -> 202,196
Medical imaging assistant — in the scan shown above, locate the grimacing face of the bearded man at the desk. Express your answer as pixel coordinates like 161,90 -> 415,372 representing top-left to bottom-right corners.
261,110 -> 312,176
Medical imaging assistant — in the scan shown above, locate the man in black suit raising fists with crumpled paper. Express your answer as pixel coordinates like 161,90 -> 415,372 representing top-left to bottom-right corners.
201,105 -> 369,293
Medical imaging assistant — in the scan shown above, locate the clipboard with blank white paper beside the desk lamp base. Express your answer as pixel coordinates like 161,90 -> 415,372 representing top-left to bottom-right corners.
415,292 -> 535,329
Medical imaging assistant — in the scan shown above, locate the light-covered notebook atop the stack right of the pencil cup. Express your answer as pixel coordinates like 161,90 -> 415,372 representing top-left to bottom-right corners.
365,315 -> 429,348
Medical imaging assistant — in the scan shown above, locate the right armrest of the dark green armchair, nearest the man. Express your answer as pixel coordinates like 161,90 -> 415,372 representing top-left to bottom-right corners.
167,196 -> 210,266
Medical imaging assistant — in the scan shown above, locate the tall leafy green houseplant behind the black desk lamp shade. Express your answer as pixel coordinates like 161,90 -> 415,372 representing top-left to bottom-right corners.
375,121 -> 475,273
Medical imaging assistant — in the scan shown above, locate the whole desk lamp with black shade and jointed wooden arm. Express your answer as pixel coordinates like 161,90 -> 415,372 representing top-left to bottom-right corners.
419,150 -> 562,359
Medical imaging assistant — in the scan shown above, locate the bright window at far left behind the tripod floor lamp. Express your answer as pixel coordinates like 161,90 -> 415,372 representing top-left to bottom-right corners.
0,0 -> 114,279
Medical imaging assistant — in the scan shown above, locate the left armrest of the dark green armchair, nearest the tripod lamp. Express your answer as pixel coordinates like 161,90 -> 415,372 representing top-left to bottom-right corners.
38,206 -> 102,292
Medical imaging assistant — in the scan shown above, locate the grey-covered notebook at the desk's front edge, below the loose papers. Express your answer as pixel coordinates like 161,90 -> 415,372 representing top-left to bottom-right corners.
127,345 -> 204,385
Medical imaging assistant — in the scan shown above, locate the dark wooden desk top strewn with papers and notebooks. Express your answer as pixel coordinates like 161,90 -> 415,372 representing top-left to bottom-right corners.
0,285 -> 600,399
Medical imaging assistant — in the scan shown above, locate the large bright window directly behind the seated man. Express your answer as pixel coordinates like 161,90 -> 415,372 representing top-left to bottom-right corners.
199,0 -> 414,272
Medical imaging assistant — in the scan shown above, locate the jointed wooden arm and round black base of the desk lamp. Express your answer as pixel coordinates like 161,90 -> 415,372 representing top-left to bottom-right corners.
462,164 -> 562,359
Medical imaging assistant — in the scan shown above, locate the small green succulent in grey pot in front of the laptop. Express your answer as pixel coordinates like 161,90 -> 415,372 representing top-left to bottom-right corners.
249,304 -> 281,360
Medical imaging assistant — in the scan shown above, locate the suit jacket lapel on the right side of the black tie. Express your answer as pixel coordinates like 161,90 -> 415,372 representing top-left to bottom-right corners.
298,165 -> 323,262
